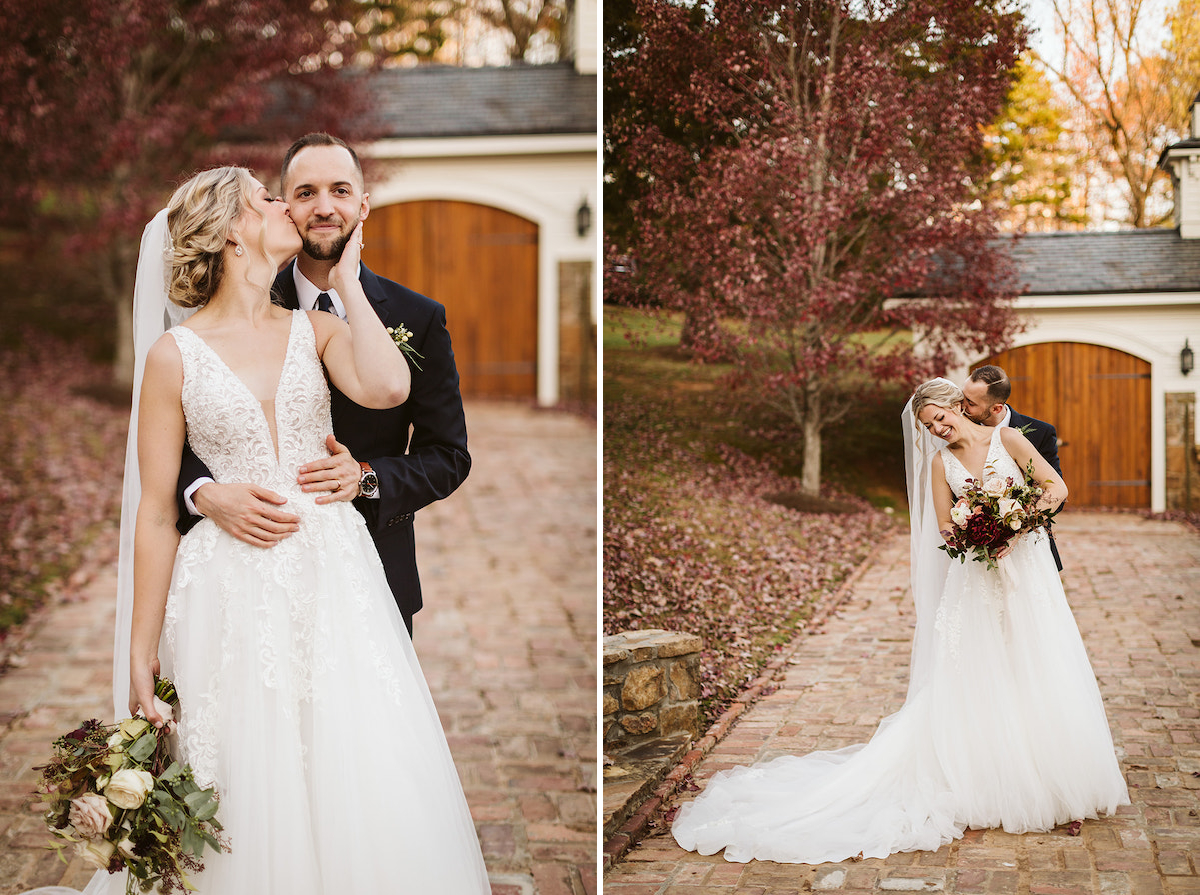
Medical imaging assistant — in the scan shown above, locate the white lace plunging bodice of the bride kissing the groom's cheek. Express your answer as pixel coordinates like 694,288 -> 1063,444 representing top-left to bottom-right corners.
169,304 -> 334,494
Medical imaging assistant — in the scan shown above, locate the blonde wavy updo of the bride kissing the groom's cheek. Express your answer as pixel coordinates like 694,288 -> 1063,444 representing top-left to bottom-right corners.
167,167 -> 265,307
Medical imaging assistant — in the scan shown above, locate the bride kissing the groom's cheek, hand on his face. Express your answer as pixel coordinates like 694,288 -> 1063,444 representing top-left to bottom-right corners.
38,168 -> 491,895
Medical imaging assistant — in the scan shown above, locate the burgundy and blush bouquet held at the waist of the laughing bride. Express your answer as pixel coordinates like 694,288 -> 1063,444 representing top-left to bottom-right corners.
938,461 -> 1062,569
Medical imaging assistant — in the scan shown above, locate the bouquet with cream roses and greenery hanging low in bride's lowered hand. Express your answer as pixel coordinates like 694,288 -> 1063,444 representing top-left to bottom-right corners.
37,678 -> 228,895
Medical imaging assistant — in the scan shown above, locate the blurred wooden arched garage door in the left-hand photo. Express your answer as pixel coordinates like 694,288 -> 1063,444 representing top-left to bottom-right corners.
362,200 -> 538,398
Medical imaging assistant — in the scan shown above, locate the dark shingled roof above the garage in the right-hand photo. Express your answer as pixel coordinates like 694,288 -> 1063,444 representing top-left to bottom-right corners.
1013,229 -> 1200,295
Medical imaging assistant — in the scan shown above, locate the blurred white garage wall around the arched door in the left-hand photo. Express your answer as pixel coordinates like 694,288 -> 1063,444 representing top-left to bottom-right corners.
364,134 -> 600,407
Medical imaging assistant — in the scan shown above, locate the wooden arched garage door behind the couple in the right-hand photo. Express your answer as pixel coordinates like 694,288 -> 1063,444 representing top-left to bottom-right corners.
986,342 -> 1150,507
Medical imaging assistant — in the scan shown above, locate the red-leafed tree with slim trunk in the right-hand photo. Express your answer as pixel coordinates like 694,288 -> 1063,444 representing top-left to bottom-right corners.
606,0 -> 1025,493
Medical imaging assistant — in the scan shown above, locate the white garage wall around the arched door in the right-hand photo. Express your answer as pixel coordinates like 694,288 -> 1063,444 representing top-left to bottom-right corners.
950,293 -> 1200,512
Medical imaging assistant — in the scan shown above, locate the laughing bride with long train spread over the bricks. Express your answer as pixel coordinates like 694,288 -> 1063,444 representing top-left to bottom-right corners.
671,379 -> 1129,864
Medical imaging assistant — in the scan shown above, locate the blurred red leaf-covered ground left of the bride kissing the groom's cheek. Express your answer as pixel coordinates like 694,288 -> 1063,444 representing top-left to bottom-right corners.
0,330 -> 130,641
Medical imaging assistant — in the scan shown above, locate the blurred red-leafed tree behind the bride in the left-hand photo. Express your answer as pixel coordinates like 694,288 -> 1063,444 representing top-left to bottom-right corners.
0,0 -> 379,380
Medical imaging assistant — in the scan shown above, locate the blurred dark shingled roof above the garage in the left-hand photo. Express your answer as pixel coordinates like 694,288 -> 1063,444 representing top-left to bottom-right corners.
368,62 -> 596,138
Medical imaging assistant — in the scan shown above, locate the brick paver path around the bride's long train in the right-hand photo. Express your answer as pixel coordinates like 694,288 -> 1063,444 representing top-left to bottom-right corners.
604,512 -> 1200,895
